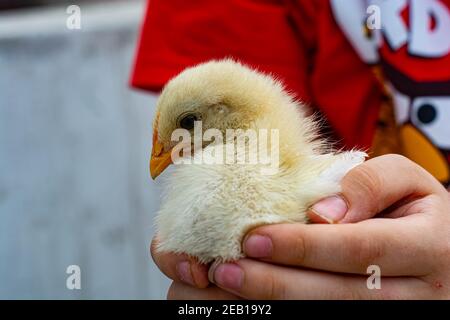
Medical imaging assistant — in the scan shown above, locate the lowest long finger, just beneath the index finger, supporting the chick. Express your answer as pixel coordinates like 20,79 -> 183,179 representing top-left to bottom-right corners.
210,259 -> 432,300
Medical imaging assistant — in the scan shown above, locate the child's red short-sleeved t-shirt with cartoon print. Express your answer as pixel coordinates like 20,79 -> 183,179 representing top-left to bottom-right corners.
131,0 -> 450,183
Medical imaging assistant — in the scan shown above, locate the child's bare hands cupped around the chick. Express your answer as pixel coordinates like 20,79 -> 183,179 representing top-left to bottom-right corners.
158,155 -> 450,299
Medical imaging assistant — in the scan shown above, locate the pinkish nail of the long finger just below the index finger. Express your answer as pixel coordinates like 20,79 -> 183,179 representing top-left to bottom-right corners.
210,263 -> 244,291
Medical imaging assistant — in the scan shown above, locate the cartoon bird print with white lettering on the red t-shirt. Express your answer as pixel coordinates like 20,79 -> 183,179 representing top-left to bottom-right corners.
330,0 -> 450,186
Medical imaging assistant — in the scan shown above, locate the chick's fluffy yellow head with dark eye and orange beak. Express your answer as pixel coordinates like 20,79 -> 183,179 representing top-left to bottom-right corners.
150,59 -> 314,178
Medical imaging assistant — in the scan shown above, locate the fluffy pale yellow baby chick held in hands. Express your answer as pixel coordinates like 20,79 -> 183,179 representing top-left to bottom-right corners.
150,59 -> 366,263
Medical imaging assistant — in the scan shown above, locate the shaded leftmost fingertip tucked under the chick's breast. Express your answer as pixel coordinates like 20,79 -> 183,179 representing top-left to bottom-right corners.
150,237 -> 209,288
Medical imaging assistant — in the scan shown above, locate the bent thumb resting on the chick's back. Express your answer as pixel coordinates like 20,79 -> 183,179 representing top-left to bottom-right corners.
308,155 -> 445,223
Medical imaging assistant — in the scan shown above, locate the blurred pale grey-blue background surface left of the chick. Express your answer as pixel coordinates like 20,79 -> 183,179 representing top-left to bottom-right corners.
0,0 -> 169,299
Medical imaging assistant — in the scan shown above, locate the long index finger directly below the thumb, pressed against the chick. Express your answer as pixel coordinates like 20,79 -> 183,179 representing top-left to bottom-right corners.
243,215 -> 440,276
